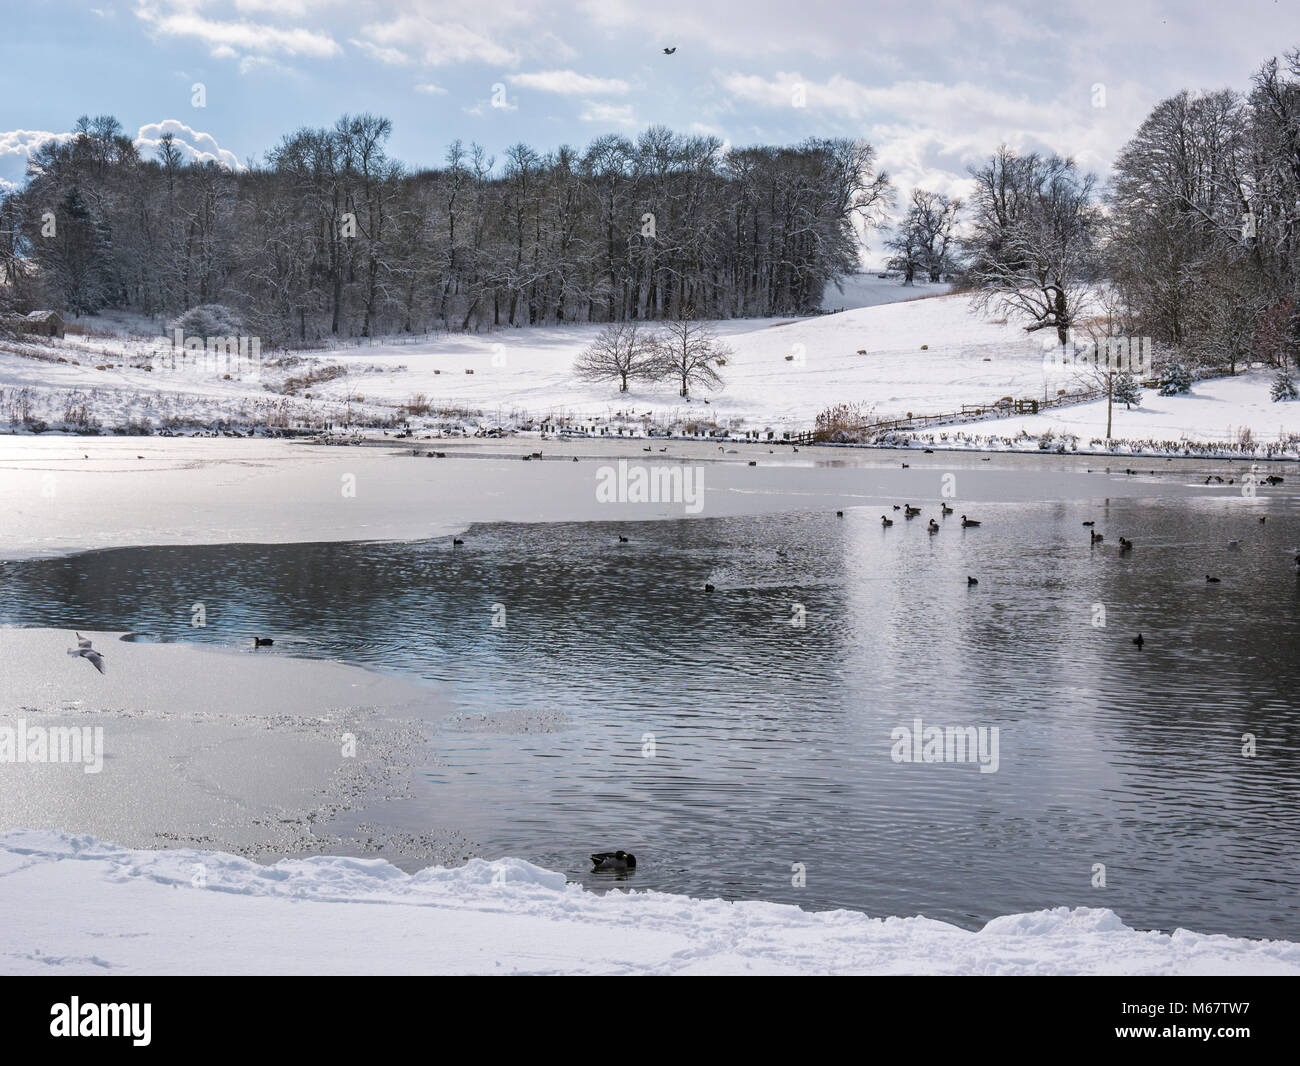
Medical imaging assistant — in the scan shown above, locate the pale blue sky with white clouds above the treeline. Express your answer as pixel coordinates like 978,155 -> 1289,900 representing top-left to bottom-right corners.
0,0 -> 1300,217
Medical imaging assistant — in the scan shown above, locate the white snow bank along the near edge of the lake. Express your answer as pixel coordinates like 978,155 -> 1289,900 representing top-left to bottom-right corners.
0,829 -> 1300,975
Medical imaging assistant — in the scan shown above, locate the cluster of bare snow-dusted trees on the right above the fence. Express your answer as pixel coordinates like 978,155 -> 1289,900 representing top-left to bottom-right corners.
956,49 -> 1300,373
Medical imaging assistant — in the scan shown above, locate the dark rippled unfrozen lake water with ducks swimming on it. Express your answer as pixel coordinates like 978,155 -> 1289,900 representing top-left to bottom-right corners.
0,470 -> 1300,939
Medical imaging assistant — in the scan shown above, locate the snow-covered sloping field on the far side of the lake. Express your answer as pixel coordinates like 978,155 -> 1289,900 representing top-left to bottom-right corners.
0,276 -> 1300,454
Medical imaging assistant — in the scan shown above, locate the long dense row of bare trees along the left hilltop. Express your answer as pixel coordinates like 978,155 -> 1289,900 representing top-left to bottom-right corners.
0,114 -> 891,343
